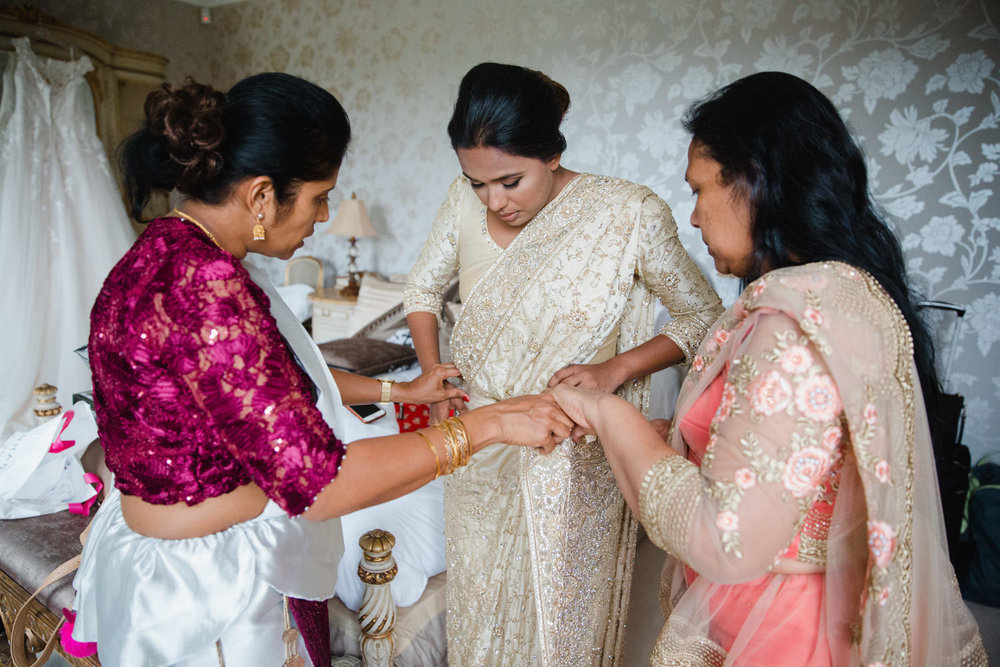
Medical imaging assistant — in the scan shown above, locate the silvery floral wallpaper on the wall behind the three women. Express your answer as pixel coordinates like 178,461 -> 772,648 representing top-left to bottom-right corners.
17,0 -> 1000,458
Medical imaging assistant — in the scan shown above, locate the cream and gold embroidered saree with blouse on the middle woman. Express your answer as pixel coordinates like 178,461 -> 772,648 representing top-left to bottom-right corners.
406,174 -> 721,667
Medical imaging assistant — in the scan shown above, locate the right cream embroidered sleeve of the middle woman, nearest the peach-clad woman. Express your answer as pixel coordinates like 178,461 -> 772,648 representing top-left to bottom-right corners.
638,192 -> 723,362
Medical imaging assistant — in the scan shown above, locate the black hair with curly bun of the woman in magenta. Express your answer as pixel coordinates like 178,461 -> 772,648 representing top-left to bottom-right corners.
119,73 -> 351,220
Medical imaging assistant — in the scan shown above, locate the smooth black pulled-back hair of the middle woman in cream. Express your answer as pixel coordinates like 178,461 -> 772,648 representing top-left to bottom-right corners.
448,63 -> 569,161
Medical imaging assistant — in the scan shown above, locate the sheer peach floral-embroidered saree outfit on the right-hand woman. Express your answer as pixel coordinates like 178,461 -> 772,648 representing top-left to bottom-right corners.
640,262 -> 986,667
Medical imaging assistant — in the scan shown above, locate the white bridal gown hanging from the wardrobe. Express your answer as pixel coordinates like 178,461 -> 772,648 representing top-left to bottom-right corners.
0,38 -> 134,442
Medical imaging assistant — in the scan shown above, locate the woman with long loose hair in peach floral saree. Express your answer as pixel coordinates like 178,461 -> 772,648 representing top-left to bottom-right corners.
553,72 -> 987,667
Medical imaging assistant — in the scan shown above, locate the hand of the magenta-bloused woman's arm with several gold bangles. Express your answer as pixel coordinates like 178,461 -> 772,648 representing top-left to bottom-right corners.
469,392 -> 573,454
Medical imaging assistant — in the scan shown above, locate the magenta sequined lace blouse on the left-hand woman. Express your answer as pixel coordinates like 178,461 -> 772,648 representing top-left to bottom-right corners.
89,218 -> 344,515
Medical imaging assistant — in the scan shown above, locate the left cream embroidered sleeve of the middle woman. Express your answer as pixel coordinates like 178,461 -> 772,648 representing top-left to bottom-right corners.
403,176 -> 469,315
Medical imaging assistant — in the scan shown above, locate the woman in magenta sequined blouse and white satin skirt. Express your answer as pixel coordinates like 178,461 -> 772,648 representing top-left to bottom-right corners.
73,74 -> 571,667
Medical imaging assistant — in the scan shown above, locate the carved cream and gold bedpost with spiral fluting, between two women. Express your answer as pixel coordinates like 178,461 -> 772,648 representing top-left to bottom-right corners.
358,528 -> 399,667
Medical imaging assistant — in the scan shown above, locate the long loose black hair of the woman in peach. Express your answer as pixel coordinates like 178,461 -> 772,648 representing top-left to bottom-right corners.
683,72 -> 941,408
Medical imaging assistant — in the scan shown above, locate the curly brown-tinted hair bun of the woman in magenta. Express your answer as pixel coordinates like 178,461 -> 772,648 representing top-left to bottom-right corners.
145,77 -> 226,189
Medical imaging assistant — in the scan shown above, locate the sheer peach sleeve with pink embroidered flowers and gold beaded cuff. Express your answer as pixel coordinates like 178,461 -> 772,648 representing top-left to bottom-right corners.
639,313 -> 842,583
